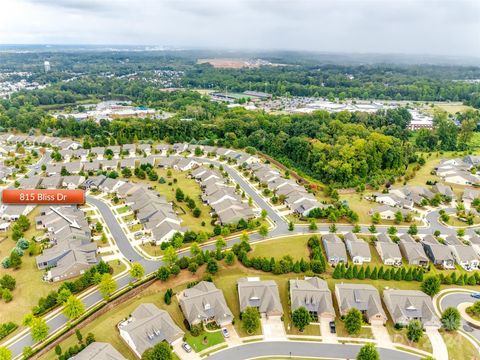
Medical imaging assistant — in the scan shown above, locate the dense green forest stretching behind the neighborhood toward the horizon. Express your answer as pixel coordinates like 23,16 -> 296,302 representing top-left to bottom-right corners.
0,53 -> 480,187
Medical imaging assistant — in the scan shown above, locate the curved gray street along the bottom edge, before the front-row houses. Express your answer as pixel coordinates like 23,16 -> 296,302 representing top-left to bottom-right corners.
208,341 -> 420,360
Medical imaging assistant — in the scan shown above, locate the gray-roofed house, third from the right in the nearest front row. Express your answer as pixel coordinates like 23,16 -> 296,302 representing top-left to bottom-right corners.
289,277 -> 335,320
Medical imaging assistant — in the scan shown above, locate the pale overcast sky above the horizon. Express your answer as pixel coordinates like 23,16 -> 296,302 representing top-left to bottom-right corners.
0,0 -> 480,56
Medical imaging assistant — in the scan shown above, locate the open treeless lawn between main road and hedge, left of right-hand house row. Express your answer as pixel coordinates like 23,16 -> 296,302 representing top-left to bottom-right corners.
249,235 -> 311,260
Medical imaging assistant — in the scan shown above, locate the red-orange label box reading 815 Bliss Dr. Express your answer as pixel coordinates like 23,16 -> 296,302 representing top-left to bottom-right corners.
2,189 -> 85,205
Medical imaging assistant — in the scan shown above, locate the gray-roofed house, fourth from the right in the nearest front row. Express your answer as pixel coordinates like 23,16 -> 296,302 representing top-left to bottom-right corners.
237,277 -> 283,317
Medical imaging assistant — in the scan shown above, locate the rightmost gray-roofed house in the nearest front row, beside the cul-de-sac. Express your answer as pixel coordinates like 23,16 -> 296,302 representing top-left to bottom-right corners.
383,289 -> 441,328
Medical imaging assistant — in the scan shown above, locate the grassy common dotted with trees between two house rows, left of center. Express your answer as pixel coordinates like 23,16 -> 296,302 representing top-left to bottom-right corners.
131,169 -> 213,233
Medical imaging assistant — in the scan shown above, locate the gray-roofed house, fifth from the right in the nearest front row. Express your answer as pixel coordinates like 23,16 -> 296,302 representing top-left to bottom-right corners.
177,281 -> 233,326
